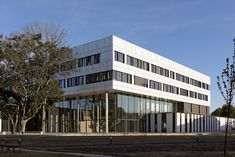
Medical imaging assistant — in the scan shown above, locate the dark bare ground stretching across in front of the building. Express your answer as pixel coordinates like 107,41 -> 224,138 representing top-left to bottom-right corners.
0,135 -> 235,157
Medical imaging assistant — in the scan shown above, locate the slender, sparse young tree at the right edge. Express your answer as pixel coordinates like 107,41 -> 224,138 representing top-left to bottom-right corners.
217,39 -> 235,157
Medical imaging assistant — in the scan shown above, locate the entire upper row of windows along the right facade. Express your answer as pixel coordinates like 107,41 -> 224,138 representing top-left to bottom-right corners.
115,51 -> 209,90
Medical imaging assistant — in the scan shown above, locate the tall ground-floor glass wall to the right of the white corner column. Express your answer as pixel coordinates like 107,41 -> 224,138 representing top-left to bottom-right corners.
109,94 -> 174,132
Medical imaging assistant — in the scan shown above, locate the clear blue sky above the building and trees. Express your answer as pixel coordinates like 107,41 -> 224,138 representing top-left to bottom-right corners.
0,0 -> 235,111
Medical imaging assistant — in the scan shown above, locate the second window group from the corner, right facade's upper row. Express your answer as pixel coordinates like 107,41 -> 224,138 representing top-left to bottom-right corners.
126,55 -> 149,71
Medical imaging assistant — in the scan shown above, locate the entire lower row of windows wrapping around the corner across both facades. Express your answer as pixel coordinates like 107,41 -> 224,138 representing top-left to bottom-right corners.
59,70 -> 208,101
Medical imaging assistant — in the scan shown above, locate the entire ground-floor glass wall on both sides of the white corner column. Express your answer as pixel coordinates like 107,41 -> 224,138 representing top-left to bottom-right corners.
56,93 -> 176,133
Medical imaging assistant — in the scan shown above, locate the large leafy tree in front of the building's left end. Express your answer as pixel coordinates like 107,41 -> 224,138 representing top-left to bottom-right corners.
0,34 -> 71,133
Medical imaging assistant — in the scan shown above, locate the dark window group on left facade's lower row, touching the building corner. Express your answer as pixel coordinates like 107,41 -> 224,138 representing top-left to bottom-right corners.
86,70 -> 113,84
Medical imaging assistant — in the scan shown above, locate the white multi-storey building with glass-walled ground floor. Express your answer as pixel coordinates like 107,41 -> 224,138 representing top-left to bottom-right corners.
47,36 -> 234,133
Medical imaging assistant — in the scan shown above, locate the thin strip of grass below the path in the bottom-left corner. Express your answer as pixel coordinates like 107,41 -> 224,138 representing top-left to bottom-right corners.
0,151 -> 82,157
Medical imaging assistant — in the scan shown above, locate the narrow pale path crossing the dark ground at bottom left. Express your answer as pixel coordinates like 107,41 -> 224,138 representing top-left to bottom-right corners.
22,149 -> 114,157
